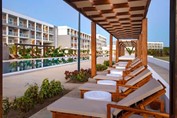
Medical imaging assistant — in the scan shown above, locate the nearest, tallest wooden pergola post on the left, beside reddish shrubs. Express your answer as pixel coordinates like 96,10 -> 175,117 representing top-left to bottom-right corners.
91,22 -> 96,77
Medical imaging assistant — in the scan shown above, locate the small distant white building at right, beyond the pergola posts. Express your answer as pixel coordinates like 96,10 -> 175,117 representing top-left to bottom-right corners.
148,42 -> 163,50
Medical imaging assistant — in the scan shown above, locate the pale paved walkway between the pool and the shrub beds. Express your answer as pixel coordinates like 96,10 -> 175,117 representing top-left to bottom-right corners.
3,57 -> 108,98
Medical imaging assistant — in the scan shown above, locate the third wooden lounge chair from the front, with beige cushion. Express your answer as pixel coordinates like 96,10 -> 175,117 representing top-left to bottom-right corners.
93,66 -> 147,83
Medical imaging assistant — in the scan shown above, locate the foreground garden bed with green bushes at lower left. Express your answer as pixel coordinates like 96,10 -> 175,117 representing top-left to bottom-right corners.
3,79 -> 69,118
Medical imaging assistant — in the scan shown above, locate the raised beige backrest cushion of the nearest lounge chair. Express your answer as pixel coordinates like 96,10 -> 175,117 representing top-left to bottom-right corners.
113,79 -> 164,115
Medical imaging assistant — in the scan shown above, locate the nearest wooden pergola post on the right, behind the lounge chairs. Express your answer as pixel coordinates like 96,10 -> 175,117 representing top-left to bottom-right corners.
142,18 -> 147,65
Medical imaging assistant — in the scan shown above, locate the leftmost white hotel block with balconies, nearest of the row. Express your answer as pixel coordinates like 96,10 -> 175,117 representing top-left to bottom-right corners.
2,9 -> 57,46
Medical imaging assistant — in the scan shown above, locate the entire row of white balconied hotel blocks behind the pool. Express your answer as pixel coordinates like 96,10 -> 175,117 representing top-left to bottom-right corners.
2,8 -> 106,51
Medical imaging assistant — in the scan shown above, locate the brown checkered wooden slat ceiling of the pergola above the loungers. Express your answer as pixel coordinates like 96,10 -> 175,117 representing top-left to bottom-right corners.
64,0 -> 150,39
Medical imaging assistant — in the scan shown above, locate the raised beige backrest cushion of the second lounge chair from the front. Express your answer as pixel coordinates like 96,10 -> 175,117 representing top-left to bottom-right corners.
122,69 -> 152,92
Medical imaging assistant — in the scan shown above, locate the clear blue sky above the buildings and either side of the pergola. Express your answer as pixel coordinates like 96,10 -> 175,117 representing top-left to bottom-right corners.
2,0 -> 170,46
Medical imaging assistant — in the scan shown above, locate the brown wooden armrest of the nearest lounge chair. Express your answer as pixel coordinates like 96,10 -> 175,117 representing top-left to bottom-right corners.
107,104 -> 169,118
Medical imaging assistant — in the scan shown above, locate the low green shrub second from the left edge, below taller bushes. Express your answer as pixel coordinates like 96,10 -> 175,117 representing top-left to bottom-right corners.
13,96 -> 34,112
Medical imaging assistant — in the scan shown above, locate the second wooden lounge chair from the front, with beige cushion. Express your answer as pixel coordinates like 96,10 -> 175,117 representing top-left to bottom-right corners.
79,69 -> 152,101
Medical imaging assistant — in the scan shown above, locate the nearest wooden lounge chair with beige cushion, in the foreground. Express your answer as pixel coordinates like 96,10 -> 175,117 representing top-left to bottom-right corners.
47,79 -> 169,118
